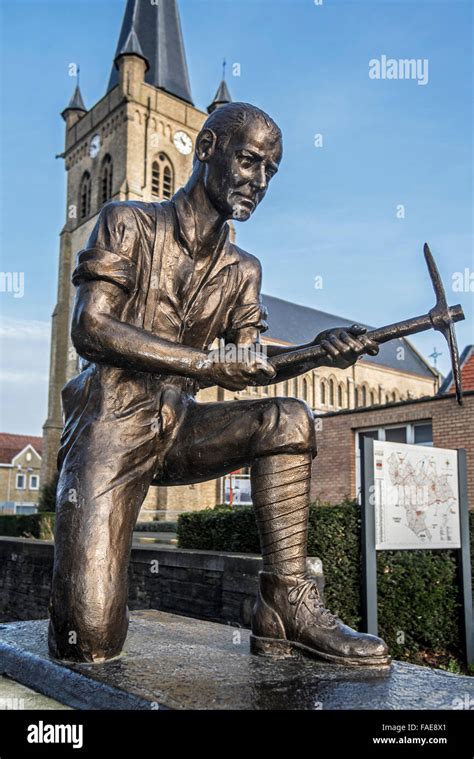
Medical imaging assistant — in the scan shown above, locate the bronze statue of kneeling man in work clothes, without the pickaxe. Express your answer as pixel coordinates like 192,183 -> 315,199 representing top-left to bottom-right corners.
49,103 -> 390,665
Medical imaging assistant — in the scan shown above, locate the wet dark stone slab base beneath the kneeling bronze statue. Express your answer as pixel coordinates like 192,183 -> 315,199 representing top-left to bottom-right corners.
0,610 -> 474,710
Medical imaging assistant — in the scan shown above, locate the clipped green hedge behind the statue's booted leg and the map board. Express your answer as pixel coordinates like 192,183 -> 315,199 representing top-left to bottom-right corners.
178,502 -> 474,671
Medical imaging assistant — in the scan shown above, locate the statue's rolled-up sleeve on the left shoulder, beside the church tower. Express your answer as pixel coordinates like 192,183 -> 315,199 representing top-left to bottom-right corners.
72,202 -> 137,293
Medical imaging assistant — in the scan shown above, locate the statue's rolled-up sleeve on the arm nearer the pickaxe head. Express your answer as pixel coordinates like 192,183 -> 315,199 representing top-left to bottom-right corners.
226,254 -> 268,342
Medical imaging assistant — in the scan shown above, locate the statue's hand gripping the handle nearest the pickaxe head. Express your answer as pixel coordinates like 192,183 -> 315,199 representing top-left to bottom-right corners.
314,324 -> 379,369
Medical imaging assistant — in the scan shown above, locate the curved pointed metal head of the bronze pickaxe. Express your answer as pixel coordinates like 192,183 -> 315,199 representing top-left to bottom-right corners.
423,242 -> 464,405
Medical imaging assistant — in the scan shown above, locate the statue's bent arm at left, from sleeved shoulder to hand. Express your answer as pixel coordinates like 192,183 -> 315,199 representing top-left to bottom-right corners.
71,203 -> 273,390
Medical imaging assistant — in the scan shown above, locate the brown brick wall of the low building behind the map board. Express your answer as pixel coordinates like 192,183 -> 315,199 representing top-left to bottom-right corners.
311,391 -> 474,508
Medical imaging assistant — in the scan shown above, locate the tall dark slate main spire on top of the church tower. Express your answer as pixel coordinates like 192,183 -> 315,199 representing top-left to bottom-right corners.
107,0 -> 193,105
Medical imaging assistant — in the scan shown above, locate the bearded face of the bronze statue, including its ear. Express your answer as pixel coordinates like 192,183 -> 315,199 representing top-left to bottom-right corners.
204,119 -> 282,221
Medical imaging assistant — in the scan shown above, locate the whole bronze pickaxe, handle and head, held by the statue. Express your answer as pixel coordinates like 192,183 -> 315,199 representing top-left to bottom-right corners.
269,243 -> 465,405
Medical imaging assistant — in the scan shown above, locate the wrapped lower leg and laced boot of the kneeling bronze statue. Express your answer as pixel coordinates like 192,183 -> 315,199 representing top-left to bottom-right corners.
250,454 -> 390,666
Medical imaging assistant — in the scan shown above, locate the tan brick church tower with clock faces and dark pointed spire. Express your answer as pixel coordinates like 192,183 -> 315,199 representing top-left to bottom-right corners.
42,0 -> 230,490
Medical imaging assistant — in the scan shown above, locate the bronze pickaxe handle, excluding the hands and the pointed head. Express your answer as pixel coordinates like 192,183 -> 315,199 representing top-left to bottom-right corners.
269,305 -> 464,372
